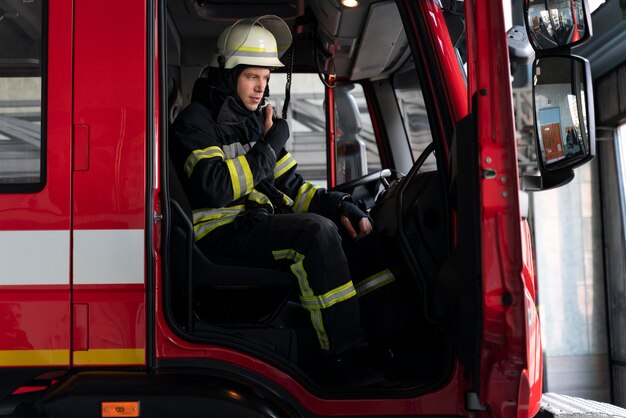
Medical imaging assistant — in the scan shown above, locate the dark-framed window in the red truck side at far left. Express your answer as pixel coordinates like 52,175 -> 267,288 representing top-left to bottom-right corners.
0,0 -> 43,191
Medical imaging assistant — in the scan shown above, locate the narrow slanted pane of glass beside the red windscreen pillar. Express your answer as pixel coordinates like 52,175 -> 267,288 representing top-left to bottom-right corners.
392,68 -> 437,171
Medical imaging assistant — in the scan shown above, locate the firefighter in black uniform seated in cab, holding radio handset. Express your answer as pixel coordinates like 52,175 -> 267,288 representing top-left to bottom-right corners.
171,16 -> 393,386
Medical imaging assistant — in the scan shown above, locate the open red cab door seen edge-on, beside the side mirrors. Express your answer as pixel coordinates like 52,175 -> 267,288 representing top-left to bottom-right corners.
466,1 -> 542,416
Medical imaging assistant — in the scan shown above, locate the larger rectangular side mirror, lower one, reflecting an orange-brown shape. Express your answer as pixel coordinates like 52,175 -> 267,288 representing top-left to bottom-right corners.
533,55 -> 596,173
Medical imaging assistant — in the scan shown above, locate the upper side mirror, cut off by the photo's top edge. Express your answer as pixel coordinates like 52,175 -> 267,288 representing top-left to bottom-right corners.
524,0 -> 592,51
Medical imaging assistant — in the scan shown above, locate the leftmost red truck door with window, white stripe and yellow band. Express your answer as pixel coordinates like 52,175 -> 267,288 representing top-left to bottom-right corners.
0,0 -> 72,366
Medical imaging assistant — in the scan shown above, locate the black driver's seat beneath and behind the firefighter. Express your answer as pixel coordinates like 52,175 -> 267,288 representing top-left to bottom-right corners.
168,154 -> 295,331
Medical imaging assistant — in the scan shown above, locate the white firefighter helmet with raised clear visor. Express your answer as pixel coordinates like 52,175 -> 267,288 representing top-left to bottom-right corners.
209,15 -> 292,69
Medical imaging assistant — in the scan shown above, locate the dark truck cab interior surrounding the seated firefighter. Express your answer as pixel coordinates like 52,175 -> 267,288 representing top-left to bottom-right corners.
160,0 -> 462,397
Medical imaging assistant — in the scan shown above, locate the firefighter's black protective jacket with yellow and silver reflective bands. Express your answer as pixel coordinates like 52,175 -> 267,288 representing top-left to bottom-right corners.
170,79 -> 348,240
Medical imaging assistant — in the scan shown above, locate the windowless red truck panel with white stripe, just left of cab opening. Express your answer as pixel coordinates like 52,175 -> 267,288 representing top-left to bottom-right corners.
71,0 -> 148,366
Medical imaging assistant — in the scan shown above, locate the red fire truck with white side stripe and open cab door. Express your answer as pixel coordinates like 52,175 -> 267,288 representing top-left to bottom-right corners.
0,0 -> 594,417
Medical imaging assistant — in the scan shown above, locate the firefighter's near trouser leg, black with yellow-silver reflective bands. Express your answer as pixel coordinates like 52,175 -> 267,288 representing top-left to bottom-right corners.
197,211 -> 366,354
